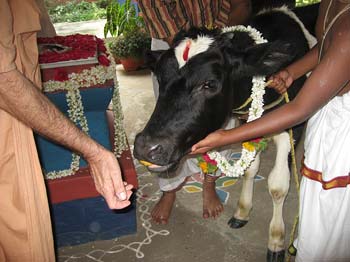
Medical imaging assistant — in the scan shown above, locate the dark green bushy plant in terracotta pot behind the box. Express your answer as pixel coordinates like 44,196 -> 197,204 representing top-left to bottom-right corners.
109,28 -> 151,71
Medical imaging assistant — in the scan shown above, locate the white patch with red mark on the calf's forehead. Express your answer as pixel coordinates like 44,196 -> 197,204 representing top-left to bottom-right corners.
175,35 -> 214,68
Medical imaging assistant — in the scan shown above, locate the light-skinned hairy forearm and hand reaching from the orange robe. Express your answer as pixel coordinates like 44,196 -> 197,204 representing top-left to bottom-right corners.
0,69 -> 132,209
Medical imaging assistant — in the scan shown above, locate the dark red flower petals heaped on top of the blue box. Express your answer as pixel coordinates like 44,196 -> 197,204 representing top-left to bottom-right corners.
38,34 -> 110,66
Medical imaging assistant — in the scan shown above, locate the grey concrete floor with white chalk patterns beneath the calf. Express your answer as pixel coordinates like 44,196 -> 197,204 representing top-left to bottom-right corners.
58,66 -> 300,262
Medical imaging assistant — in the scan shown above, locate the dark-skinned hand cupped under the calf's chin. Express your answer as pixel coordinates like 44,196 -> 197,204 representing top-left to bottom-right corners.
190,129 -> 226,155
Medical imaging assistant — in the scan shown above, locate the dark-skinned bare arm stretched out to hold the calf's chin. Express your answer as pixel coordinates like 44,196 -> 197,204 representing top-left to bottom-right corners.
192,15 -> 350,154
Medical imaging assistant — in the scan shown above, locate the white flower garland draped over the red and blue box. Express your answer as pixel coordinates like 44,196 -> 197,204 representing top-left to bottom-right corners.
43,56 -> 128,179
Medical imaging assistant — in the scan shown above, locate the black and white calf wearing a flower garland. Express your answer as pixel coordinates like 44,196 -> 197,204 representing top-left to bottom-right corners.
134,4 -> 318,260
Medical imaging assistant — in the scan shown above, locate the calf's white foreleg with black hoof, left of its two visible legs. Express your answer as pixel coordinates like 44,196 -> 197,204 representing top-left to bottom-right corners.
228,153 -> 260,228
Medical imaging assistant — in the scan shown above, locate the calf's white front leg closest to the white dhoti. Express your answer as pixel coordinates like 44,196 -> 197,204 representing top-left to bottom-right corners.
267,132 -> 291,261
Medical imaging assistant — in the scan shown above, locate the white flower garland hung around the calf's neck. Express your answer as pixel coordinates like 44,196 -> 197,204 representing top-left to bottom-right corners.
202,25 -> 267,177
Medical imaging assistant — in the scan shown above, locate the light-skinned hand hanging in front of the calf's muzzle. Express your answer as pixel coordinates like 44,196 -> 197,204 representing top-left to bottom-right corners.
87,149 -> 133,209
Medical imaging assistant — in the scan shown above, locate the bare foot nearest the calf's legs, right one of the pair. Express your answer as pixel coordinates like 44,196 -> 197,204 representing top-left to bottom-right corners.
203,175 -> 224,218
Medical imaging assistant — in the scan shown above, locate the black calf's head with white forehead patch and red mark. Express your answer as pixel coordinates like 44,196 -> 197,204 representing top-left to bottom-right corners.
134,29 -> 293,172
